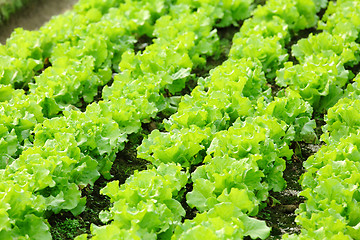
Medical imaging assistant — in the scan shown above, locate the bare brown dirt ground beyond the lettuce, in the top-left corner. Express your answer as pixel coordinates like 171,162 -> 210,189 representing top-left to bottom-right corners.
0,0 -> 78,44
